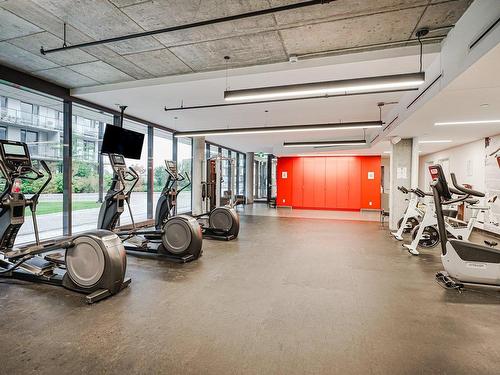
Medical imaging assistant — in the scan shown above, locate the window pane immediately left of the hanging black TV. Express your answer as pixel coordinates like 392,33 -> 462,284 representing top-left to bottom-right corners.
72,105 -> 113,233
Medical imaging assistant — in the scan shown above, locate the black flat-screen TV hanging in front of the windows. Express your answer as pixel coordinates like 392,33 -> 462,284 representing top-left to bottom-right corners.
101,124 -> 144,159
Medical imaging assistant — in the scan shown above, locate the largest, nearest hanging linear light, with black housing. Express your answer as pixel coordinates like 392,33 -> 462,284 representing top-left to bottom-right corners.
224,72 -> 425,101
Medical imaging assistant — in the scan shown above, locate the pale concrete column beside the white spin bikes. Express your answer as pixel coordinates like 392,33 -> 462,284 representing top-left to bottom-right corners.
389,139 -> 418,230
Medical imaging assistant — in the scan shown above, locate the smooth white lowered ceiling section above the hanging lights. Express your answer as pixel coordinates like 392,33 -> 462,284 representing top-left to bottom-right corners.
72,46 -> 439,155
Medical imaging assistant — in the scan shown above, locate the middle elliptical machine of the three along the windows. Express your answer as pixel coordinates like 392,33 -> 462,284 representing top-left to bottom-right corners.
98,154 -> 203,263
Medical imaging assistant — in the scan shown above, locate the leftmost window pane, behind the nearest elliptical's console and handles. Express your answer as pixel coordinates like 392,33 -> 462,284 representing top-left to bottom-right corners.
0,84 -> 63,243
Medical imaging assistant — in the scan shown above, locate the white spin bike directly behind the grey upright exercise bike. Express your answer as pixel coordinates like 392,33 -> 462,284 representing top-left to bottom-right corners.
403,188 -> 488,255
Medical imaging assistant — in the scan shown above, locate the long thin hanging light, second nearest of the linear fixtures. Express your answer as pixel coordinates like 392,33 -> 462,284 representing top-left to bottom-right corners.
174,121 -> 382,138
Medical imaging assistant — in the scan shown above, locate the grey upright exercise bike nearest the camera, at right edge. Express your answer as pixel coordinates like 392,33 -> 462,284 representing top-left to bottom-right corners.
429,165 -> 500,290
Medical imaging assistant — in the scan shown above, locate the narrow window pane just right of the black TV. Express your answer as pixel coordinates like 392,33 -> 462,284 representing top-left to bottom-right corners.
153,129 -> 173,215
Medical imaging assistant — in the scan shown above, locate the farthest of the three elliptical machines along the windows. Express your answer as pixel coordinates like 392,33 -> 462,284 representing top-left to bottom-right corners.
160,160 -> 240,241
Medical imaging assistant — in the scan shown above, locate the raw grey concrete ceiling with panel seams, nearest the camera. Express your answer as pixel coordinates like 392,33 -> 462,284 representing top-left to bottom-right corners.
0,0 -> 472,88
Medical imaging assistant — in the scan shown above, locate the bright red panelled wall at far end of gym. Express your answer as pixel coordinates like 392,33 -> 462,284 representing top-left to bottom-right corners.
277,156 -> 381,210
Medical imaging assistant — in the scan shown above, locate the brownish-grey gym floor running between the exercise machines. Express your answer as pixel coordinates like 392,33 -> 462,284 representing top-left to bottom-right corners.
0,215 -> 500,375
